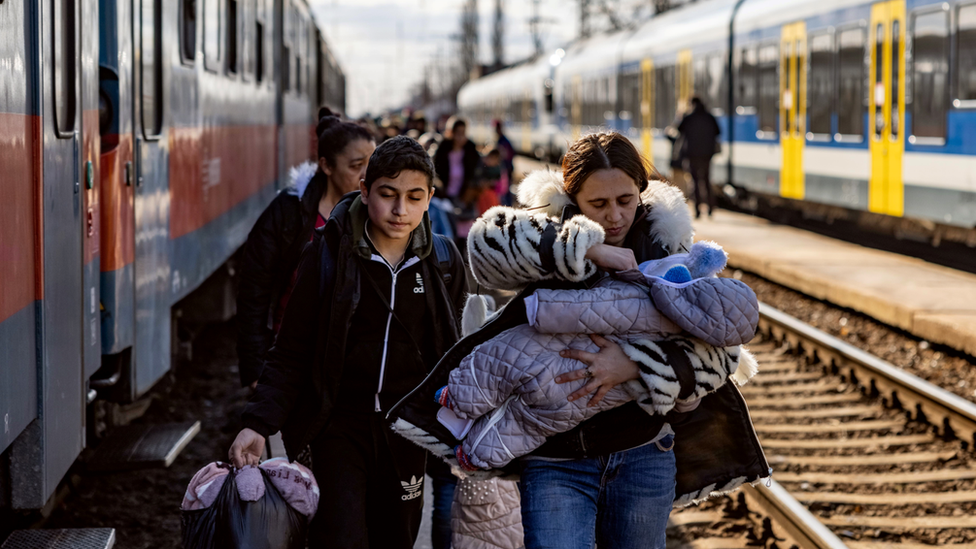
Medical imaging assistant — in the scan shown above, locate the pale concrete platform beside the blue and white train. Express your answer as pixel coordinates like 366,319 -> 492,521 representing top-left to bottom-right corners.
695,210 -> 976,356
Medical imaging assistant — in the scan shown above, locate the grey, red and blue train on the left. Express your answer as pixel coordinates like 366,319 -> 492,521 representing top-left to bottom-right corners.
0,0 -> 345,512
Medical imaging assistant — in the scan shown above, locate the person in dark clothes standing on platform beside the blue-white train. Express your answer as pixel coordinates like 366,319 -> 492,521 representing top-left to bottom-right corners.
678,97 -> 722,219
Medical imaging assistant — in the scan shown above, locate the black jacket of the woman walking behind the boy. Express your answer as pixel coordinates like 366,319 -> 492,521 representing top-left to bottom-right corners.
237,163 -> 327,387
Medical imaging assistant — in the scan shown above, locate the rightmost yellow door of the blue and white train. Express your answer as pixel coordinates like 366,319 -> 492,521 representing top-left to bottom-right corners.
868,0 -> 905,216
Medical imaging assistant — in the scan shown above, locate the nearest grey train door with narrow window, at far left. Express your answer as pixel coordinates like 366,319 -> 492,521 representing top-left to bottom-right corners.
29,0 -> 87,508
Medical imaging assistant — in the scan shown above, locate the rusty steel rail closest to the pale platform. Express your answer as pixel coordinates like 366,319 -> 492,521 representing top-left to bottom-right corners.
759,303 -> 976,444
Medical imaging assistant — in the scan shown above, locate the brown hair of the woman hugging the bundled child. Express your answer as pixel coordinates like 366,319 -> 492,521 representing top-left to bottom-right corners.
563,132 -> 665,196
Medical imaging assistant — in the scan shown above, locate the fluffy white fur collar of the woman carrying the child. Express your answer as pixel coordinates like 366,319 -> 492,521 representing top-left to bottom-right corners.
517,170 -> 695,253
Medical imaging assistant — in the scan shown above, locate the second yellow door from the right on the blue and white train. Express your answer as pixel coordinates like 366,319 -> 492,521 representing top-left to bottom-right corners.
779,22 -> 807,200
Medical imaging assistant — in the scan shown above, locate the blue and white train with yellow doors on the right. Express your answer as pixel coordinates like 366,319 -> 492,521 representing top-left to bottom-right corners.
458,0 -> 976,240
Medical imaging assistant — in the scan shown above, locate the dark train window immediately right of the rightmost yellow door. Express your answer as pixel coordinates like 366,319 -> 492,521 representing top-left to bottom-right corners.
912,10 -> 949,142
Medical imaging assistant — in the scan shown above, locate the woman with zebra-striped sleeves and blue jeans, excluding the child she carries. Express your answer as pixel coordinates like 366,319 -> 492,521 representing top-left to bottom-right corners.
390,133 -> 768,549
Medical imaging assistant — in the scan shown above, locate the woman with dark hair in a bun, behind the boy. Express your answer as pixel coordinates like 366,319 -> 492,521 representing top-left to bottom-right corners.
237,107 -> 376,388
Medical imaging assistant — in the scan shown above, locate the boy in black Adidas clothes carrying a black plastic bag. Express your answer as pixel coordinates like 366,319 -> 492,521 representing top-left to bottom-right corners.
230,137 -> 467,548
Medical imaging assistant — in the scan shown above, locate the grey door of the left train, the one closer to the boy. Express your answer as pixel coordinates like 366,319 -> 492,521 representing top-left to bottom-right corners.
131,0 -> 172,397
